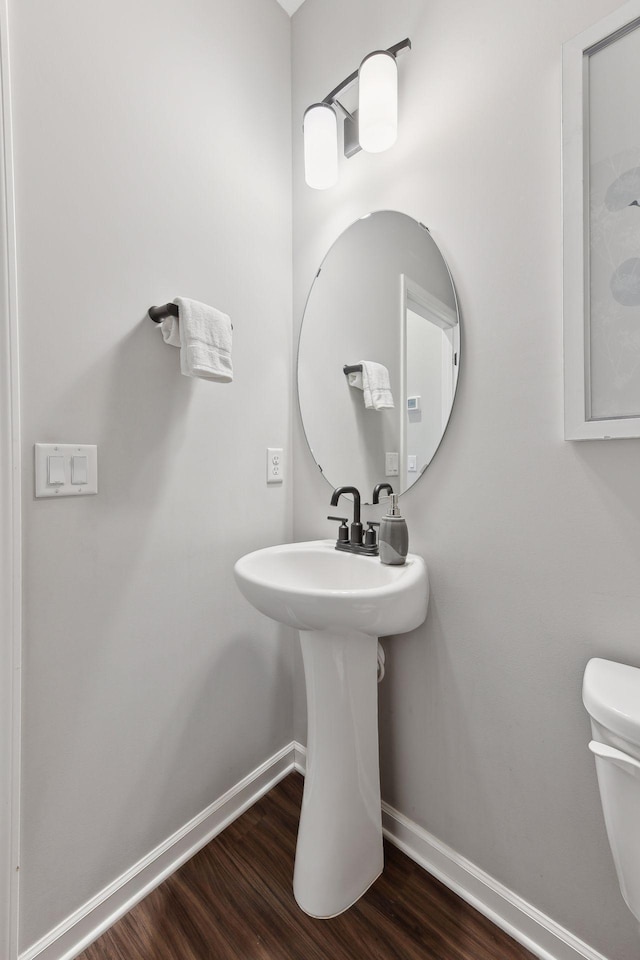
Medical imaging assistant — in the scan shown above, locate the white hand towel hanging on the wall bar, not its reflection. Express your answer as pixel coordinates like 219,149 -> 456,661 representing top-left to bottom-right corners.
161,297 -> 233,383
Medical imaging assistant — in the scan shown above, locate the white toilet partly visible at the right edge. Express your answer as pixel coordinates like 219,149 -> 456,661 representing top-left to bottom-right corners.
582,659 -> 640,920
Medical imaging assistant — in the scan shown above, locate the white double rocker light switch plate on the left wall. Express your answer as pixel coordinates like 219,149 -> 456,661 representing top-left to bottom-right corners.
35,443 -> 98,498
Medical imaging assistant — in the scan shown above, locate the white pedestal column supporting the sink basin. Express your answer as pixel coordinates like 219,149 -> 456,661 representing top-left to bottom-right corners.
293,630 -> 384,918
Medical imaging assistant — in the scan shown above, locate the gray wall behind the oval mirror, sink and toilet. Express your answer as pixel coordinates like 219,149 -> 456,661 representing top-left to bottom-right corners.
293,0 -> 640,960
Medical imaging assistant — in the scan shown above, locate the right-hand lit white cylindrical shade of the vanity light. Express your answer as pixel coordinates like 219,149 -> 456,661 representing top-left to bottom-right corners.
358,50 -> 398,153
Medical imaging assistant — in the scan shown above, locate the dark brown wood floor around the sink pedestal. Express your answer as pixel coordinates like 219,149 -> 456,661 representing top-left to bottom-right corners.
79,773 -> 533,960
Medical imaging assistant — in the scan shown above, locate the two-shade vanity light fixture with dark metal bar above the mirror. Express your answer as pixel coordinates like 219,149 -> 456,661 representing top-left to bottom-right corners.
302,38 -> 411,190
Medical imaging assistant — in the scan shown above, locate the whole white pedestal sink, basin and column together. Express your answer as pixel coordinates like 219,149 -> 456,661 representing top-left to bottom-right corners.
235,540 -> 429,918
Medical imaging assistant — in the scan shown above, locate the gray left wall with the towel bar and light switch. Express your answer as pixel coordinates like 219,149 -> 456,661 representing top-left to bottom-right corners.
10,0 -> 292,949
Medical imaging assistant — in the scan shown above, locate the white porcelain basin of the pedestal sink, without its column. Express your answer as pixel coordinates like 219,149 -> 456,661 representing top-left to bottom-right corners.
235,540 -> 429,637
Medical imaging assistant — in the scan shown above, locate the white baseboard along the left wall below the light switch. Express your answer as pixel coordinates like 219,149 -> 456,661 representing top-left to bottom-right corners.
20,743 -> 298,960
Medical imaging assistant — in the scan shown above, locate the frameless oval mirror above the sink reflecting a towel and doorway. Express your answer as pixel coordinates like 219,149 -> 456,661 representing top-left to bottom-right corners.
298,210 -> 460,502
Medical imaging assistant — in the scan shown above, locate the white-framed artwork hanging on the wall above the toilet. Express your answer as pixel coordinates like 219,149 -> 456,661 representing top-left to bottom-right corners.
562,0 -> 640,440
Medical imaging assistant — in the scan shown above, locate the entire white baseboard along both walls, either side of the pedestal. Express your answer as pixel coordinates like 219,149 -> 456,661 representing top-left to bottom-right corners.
20,740 -> 607,960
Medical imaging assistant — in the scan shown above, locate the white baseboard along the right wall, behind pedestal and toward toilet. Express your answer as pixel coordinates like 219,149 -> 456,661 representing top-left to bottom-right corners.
293,742 -> 608,960
